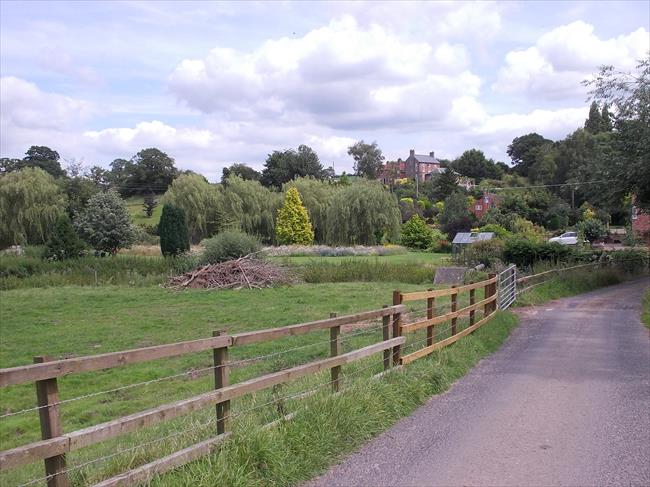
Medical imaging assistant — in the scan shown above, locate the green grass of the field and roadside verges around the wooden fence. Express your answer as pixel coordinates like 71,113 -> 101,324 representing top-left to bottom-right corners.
0,246 -> 640,486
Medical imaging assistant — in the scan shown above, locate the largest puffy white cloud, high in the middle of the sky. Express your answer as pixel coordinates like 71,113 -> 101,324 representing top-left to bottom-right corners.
169,16 -> 481,129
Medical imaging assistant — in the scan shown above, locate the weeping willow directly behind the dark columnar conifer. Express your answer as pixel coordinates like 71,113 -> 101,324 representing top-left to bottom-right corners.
162,174 -> 225,242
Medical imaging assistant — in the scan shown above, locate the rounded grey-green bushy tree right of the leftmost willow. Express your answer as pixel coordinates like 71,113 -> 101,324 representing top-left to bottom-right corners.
74,191 -> 135,254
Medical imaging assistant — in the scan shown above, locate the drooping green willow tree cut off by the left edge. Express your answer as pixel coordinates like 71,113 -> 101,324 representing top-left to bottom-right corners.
0,167 -> 67,246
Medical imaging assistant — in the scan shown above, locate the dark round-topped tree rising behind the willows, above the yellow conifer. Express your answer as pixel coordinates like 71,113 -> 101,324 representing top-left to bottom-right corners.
261,145 -> 326,188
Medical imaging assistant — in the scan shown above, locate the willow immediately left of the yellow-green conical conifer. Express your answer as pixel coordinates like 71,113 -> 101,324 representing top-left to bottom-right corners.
221,176 -> 282,242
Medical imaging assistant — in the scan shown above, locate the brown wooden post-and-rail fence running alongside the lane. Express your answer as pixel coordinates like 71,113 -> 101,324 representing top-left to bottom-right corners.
0,275 -> 497,487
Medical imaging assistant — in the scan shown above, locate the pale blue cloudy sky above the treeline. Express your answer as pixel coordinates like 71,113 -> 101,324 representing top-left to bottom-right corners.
0,0 -> 650,181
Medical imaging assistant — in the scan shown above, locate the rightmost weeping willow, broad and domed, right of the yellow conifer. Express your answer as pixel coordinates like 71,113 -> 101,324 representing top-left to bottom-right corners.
327,181 -> 401,245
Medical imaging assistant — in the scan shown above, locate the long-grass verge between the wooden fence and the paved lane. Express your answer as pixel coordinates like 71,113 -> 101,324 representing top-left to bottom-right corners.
151,313 -> 517,487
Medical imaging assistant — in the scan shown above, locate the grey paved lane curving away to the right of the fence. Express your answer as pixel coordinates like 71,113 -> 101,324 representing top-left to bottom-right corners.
308,280 -> 650,487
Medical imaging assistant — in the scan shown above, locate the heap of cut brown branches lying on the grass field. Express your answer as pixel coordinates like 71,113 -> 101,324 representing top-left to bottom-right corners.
165,255 -> 292,290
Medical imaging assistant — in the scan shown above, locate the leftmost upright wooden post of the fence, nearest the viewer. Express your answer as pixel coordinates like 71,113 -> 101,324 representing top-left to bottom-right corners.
34,356 -> 70,487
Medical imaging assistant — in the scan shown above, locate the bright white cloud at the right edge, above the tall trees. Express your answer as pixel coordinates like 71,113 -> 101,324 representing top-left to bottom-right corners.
493,21 -> 650,100
